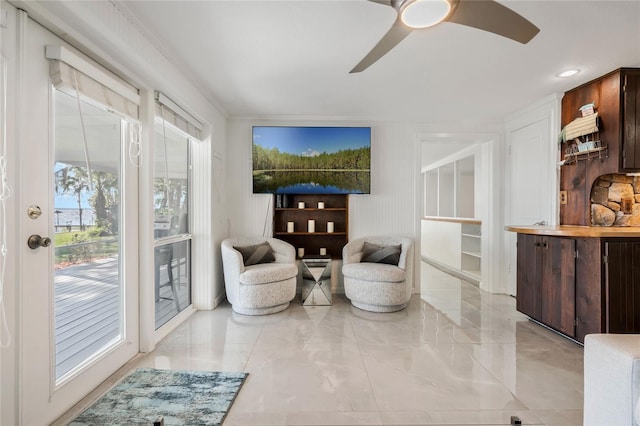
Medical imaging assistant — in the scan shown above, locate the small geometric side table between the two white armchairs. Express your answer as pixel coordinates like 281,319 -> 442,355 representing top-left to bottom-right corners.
300,256 -> 331,306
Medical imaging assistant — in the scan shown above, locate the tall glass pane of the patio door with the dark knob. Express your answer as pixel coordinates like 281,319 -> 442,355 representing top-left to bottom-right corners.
52,90 -> 127,382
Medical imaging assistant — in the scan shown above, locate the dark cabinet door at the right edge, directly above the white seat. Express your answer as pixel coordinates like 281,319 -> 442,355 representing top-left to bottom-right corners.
605,241 -> 640,333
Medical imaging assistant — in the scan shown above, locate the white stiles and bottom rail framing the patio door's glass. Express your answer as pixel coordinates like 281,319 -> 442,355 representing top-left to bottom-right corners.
15,12 -> 139,423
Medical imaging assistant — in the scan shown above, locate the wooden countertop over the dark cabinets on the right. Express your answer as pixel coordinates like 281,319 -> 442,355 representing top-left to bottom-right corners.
504,225 -> 640,238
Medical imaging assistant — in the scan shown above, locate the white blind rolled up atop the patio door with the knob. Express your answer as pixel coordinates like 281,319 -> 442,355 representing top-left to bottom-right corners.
45,45 -> 140,120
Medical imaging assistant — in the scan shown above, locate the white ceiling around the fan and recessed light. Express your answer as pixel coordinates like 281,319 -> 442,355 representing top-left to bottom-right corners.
118,0 -> 640,123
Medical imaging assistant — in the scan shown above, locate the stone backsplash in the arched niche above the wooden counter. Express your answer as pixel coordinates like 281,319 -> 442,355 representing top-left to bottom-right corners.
591,174 -> 640,226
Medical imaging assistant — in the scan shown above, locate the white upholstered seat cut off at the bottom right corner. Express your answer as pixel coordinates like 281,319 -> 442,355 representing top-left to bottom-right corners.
583,334 -> 640,426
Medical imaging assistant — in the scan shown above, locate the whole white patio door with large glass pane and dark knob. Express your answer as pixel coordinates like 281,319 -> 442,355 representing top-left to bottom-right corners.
19,15 -> 139,424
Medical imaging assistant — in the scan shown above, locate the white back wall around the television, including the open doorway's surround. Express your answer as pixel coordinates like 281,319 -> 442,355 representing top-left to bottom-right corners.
227,117 -> 504,292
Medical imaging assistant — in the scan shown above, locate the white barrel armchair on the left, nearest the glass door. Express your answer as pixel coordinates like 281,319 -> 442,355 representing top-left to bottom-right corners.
222,237 -> 298,315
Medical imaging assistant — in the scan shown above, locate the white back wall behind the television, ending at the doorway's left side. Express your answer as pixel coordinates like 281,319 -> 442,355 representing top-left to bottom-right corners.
227,118 -> 420,292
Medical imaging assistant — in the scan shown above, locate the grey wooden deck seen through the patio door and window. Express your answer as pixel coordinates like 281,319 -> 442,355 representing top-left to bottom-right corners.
55,257 -> 190,378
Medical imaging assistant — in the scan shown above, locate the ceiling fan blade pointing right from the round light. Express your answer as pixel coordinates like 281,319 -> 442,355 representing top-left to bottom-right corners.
446,0 -> 540,44
